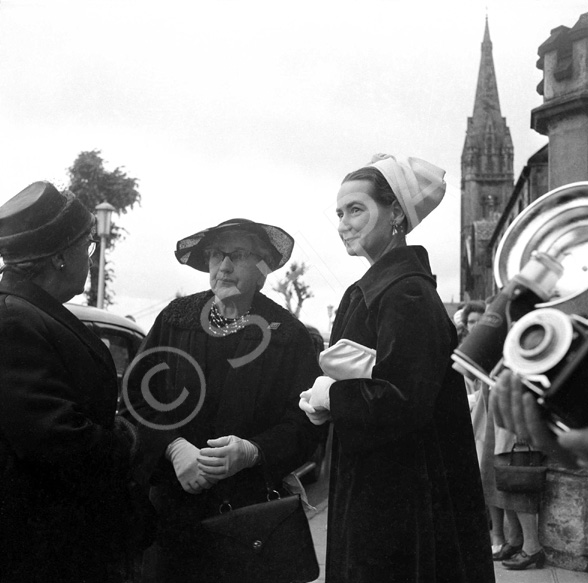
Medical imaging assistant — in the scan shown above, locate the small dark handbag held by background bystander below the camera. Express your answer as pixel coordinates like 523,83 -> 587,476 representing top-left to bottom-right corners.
494,443 -> 547,493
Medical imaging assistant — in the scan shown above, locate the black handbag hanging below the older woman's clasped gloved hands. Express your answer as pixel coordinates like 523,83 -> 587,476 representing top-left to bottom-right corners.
201,491 -> 319,583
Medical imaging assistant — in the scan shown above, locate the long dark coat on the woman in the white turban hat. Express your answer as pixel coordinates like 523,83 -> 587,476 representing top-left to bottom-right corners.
326,247 -> 494,583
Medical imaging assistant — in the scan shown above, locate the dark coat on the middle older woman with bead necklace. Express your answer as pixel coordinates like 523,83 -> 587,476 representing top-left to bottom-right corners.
128,291 -> 322,582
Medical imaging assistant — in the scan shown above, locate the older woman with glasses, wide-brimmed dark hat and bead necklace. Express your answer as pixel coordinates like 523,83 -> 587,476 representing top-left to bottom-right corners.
127,219 -> 320,583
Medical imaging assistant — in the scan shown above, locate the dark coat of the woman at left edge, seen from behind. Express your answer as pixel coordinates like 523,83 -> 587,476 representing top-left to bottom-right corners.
0,274 -> 139,583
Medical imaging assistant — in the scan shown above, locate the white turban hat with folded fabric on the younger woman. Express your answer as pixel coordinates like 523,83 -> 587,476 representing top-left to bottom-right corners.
369,154 -> 446,233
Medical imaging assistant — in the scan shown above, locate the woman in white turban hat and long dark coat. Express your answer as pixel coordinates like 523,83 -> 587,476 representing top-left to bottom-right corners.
300,156 -> 494,583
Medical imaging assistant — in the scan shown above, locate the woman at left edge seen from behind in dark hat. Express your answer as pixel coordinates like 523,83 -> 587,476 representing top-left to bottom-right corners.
0,182 -> 149,583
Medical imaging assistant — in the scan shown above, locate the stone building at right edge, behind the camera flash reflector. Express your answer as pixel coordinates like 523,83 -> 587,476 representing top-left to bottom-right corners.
484,13 -> 588,571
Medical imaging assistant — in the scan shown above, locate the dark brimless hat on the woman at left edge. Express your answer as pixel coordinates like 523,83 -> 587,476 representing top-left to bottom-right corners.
0,181 -> 94,264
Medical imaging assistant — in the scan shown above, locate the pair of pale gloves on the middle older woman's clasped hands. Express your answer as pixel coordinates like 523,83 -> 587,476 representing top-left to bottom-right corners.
165,435 -> 259,494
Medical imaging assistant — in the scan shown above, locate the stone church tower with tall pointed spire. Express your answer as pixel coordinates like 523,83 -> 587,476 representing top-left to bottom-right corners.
460,17 -> 513,300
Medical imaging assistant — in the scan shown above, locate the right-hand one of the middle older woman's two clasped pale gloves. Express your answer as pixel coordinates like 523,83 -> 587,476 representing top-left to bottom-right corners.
198,435 -> 259,480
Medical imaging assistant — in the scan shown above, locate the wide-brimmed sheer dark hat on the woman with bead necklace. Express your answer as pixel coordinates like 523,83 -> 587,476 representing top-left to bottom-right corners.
175,219 -> 294,273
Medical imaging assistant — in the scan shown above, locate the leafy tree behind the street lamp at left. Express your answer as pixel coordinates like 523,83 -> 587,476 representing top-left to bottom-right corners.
68,150 -> 141,306
